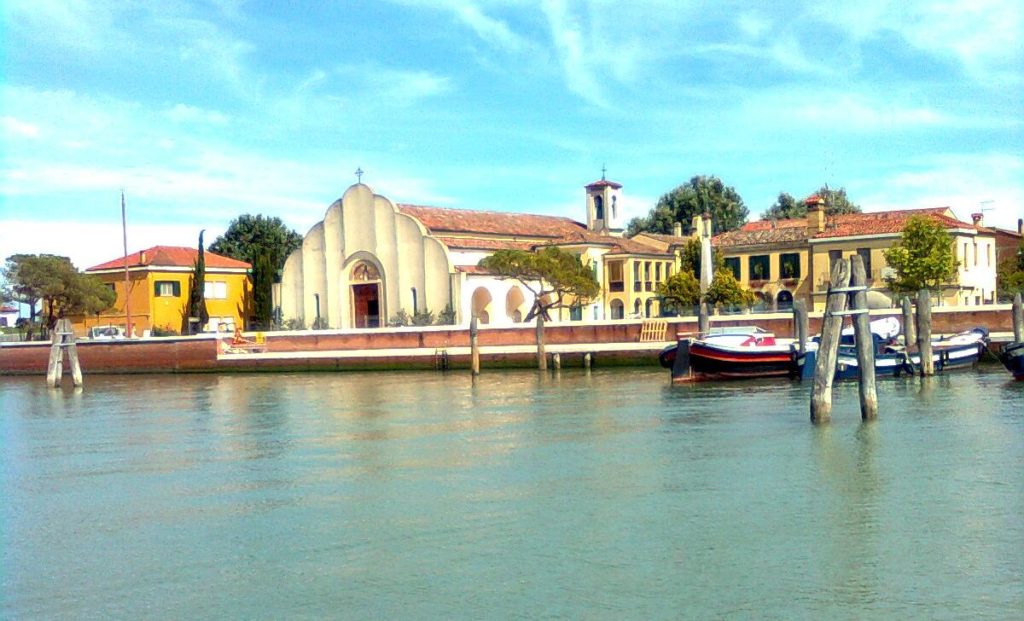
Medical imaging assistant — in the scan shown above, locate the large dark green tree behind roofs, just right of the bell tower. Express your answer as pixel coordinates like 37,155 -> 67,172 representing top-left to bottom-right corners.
628,175 -> 749,237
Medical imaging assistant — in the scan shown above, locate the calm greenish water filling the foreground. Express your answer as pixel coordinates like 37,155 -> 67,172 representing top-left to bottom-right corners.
0,367 -> 1024,619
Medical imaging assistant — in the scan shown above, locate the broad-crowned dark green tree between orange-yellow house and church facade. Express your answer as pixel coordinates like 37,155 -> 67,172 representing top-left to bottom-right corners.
210,213 -> 302,326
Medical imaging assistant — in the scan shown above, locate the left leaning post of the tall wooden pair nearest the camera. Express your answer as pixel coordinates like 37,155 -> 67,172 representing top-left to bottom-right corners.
811,258 -> 850,422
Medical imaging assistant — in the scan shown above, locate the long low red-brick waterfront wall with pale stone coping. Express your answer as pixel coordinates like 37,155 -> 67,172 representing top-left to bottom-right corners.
0,305 -> 1013,375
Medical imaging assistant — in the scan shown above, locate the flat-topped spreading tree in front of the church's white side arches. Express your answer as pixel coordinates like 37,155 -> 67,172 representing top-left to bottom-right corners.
479,246 -> 601,321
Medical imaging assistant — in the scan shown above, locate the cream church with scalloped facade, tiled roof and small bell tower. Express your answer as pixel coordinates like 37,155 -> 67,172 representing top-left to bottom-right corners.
280,175 -> 687,329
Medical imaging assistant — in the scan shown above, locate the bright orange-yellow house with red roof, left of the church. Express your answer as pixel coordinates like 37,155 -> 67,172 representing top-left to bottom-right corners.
73,246 -> 252,336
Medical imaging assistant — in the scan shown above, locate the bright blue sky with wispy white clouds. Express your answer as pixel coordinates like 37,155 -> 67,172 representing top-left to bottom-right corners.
0,0 -> 1024,268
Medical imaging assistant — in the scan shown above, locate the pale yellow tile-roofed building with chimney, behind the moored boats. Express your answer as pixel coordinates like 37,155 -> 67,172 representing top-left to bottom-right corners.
712,197 -> 995,311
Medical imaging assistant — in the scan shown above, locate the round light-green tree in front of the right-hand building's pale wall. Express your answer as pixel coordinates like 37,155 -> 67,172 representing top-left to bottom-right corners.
883,215 -> 956,293
